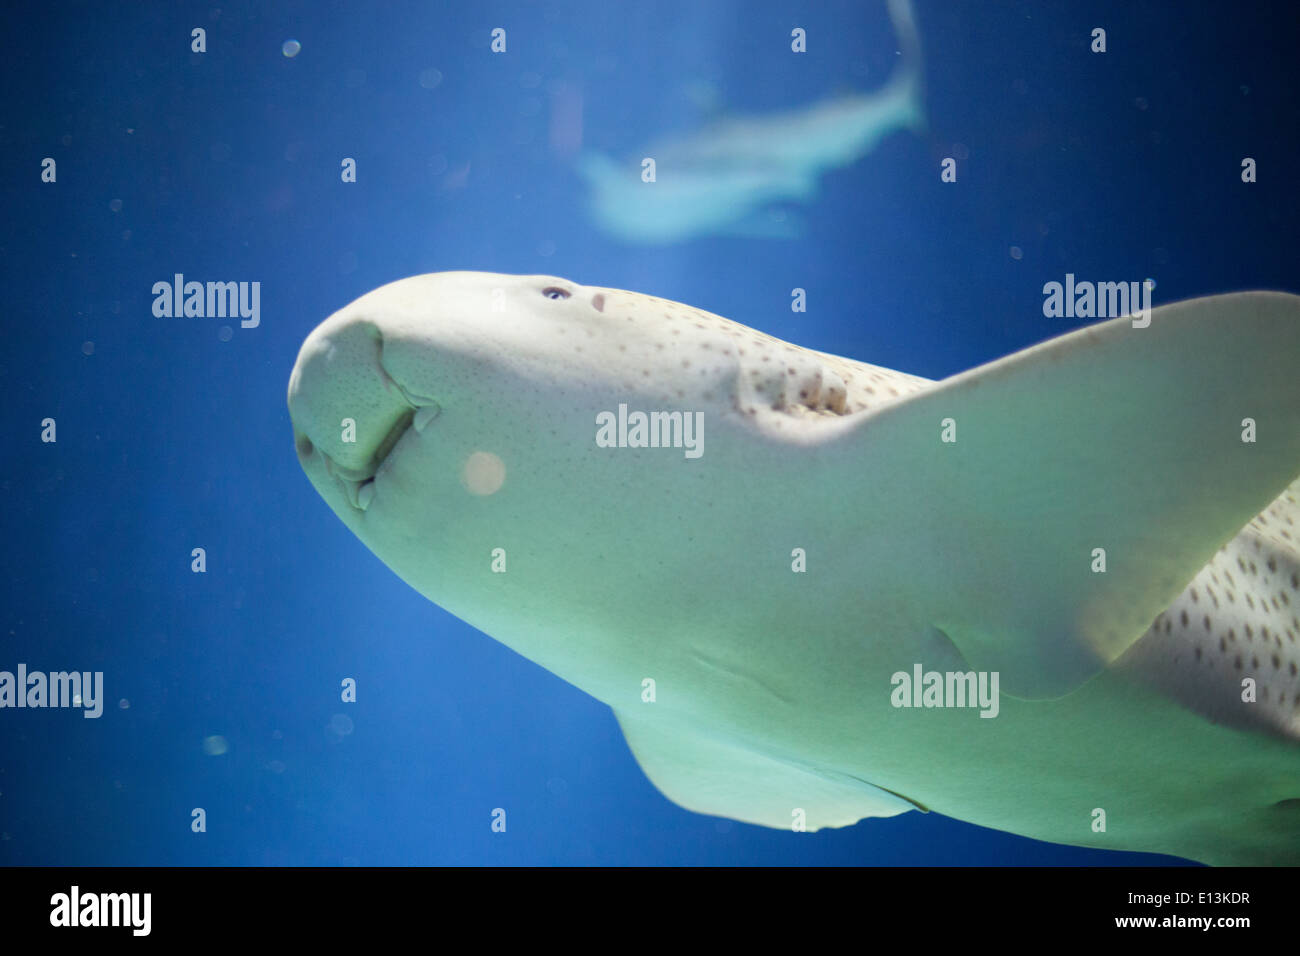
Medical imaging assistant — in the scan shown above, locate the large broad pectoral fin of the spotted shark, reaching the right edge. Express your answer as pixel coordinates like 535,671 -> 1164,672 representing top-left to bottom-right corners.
803,293 -> 1300,698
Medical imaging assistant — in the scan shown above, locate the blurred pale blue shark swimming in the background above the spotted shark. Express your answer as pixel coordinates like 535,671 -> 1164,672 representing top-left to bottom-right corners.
577,0 -> 924,245
